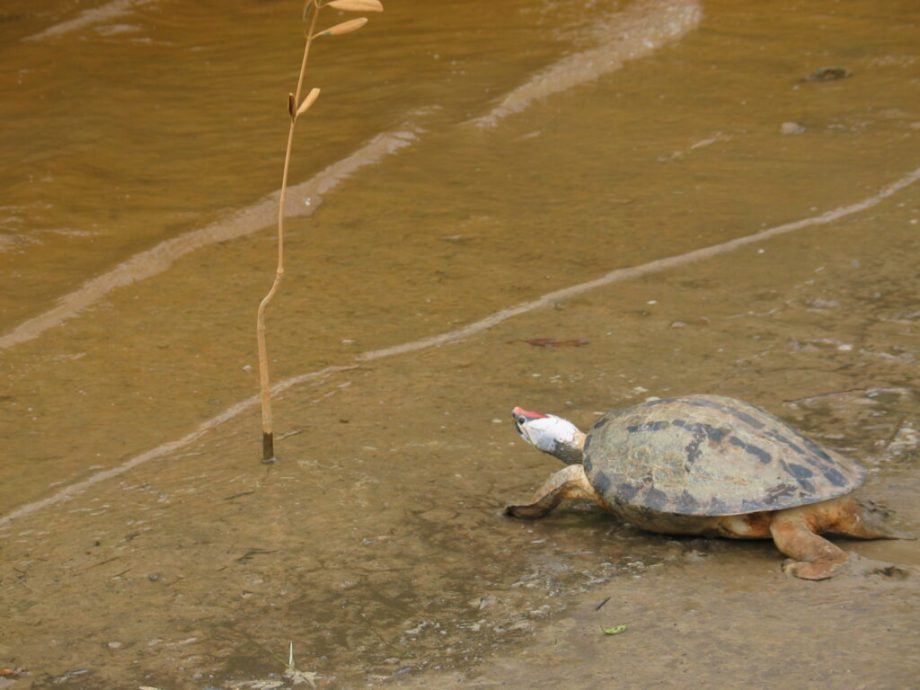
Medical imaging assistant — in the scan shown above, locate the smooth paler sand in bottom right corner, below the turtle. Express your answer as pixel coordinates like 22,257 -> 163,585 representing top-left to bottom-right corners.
390,542 -> 920,690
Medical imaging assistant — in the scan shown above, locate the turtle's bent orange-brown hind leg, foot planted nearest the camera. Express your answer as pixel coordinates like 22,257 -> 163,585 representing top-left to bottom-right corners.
770,506 -> 906,580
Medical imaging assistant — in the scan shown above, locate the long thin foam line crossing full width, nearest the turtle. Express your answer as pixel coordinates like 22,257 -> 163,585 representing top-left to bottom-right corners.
0,168 -> 920,528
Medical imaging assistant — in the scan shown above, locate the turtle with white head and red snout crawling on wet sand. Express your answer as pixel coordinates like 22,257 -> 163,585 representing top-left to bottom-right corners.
505,395 -> 913,580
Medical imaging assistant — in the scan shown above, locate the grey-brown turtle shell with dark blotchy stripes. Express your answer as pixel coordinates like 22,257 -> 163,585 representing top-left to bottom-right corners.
584,395 -> 866,515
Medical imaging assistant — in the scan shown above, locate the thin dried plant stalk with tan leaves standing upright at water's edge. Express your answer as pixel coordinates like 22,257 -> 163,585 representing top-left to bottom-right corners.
256,0 -> 383,463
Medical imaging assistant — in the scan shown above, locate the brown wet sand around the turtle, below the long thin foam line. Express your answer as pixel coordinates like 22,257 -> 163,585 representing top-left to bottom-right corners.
3,192 -> 920,688
